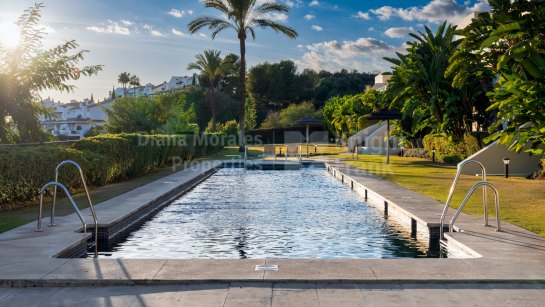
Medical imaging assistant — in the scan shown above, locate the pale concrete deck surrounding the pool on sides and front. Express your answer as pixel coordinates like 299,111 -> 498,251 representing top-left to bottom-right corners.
0,160 -> 545,290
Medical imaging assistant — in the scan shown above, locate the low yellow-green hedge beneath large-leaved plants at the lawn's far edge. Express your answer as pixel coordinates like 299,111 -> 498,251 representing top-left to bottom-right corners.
423,133 -> 482,164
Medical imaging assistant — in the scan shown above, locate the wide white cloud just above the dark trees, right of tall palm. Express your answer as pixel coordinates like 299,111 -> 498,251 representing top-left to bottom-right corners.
294,37 -> 396,71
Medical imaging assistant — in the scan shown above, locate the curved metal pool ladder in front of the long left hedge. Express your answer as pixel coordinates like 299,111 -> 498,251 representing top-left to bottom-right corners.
36,160 -> 98,258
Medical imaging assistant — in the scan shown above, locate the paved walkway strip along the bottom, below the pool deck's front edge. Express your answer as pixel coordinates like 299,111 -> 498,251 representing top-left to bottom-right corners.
0,283 -> 545,307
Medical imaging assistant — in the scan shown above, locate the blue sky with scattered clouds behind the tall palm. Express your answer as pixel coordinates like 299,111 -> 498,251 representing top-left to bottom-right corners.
0,0 -> 488,102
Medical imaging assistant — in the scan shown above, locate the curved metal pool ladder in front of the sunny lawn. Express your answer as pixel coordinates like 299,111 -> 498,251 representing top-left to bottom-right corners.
439,160 -> 501,242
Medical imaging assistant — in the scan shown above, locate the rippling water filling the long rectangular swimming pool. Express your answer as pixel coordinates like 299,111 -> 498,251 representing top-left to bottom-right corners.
106,167 -> 427,259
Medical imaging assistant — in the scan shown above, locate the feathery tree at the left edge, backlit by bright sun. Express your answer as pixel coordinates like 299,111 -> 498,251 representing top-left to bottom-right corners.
0,4 -> 102,143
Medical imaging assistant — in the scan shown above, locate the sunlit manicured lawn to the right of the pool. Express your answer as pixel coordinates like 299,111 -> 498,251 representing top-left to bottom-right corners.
338,155 -> 545,236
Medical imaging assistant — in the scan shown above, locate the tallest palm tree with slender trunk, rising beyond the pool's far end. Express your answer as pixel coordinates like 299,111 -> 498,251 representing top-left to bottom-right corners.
188,0 -> 297,151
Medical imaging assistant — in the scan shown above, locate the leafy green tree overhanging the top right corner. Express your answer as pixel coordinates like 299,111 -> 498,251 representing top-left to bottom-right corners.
451,0 -> 545,155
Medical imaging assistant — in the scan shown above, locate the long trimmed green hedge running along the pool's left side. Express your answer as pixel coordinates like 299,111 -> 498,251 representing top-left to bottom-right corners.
0,134 -> 221,210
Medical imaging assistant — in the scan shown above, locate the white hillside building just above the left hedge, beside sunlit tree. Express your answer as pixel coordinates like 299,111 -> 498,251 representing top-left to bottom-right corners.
39,98 -> 111,139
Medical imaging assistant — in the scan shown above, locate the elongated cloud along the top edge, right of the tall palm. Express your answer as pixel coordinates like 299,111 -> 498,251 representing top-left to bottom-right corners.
370,0 -> 490,23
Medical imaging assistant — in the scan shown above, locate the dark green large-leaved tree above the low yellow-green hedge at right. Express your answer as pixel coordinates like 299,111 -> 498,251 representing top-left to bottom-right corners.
385,22 -> 484,139
